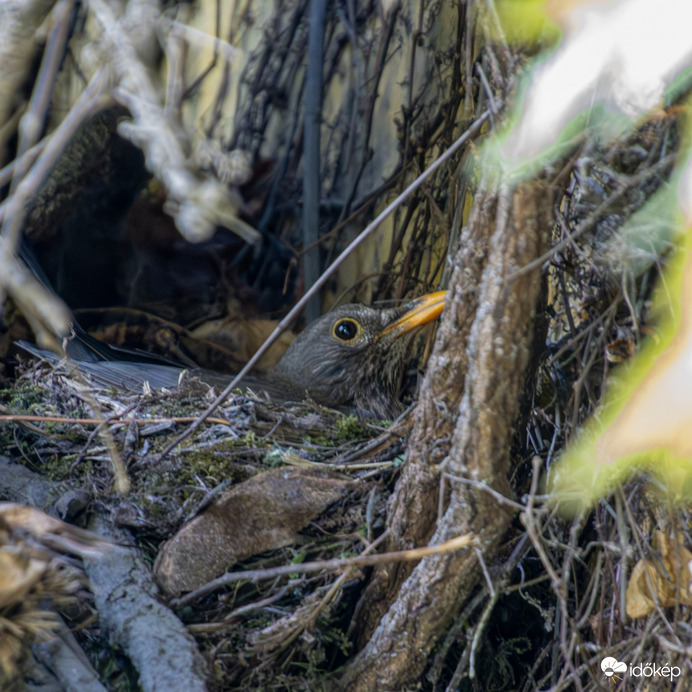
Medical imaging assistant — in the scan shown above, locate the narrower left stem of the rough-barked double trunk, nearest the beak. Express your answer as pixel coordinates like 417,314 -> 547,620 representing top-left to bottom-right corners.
356,178 -> 497,644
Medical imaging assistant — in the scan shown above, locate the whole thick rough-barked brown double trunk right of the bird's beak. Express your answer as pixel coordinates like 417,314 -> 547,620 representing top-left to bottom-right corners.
340,182 -> 552,692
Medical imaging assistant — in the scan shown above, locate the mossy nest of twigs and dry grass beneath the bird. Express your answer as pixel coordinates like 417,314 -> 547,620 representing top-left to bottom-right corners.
3,356 -> 406,689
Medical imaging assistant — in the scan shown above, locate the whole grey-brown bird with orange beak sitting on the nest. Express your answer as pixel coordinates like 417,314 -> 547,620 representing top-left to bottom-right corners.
20,291 -> 447,419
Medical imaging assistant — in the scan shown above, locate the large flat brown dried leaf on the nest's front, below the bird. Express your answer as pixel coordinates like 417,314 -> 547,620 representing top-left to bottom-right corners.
154,467 -> 353,595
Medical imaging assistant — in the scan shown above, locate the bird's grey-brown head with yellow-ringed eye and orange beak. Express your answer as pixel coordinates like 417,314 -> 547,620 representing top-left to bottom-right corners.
271,291 -> 446,418
